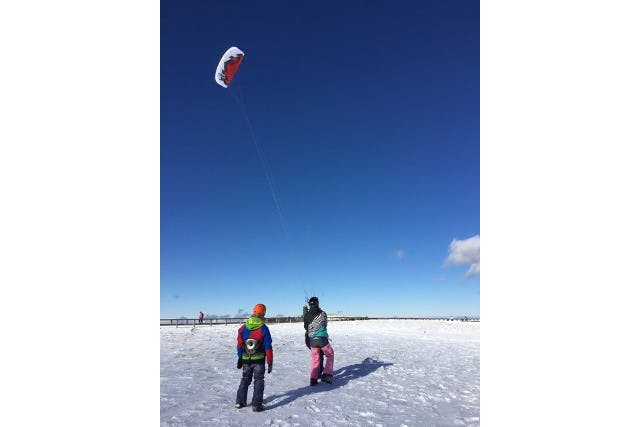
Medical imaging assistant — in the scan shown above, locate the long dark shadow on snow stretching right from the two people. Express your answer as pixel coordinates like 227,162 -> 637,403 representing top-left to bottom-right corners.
264,357 -> 393,409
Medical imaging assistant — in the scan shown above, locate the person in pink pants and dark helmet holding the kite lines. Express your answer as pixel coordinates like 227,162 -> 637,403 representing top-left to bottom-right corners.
304,297 -> 333,386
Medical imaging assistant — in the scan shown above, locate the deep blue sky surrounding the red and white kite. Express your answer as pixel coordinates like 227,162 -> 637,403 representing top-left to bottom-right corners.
160,0 -> 480,317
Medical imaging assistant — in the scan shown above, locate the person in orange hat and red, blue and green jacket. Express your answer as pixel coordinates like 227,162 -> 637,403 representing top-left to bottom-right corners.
236,304 -> 273,412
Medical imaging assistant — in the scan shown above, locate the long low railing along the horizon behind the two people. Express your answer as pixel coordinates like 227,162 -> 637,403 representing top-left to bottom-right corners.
160,315 -> 480,327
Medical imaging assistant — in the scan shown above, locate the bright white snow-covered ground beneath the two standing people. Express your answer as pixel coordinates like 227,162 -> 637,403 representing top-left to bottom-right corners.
160,320 -> 480,427
